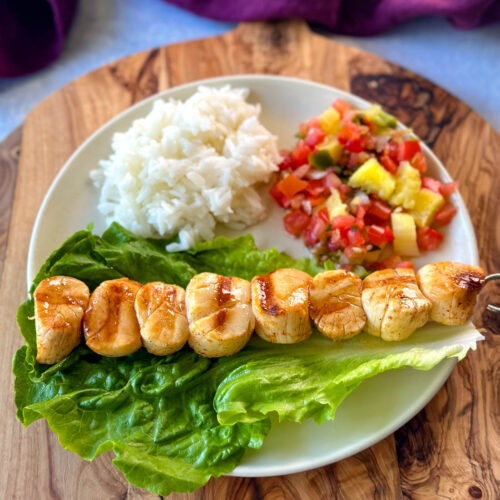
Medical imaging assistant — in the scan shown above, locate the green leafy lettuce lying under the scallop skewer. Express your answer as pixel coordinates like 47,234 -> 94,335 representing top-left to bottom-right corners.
13,224 -> 479,495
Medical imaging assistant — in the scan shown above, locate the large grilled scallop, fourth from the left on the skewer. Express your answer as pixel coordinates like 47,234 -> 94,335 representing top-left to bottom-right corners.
186,273 -> 255,358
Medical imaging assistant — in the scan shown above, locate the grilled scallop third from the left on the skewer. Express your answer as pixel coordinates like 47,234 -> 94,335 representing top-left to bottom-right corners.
134,281 -> 189,356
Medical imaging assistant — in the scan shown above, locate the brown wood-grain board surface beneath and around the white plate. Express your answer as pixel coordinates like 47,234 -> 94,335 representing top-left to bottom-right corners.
0,22 -> 500,500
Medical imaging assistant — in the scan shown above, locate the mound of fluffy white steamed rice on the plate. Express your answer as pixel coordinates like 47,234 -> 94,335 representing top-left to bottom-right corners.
90,86 -> 279,251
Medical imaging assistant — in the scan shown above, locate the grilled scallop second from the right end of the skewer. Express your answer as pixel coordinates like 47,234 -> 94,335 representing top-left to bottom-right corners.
361,269 -> 431,340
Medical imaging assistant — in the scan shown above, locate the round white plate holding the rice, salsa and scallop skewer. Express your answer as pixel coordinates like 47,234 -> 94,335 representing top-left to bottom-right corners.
27,75 -> 478,477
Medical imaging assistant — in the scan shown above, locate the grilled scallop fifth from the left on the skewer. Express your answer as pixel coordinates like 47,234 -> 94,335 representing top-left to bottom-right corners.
252,269 -> 312,344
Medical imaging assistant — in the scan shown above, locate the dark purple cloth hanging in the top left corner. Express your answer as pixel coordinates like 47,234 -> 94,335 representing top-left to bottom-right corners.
0,0 -> 78,77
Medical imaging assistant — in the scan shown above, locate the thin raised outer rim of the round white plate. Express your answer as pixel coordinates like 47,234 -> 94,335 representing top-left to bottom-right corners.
26,74 -> 479,477
